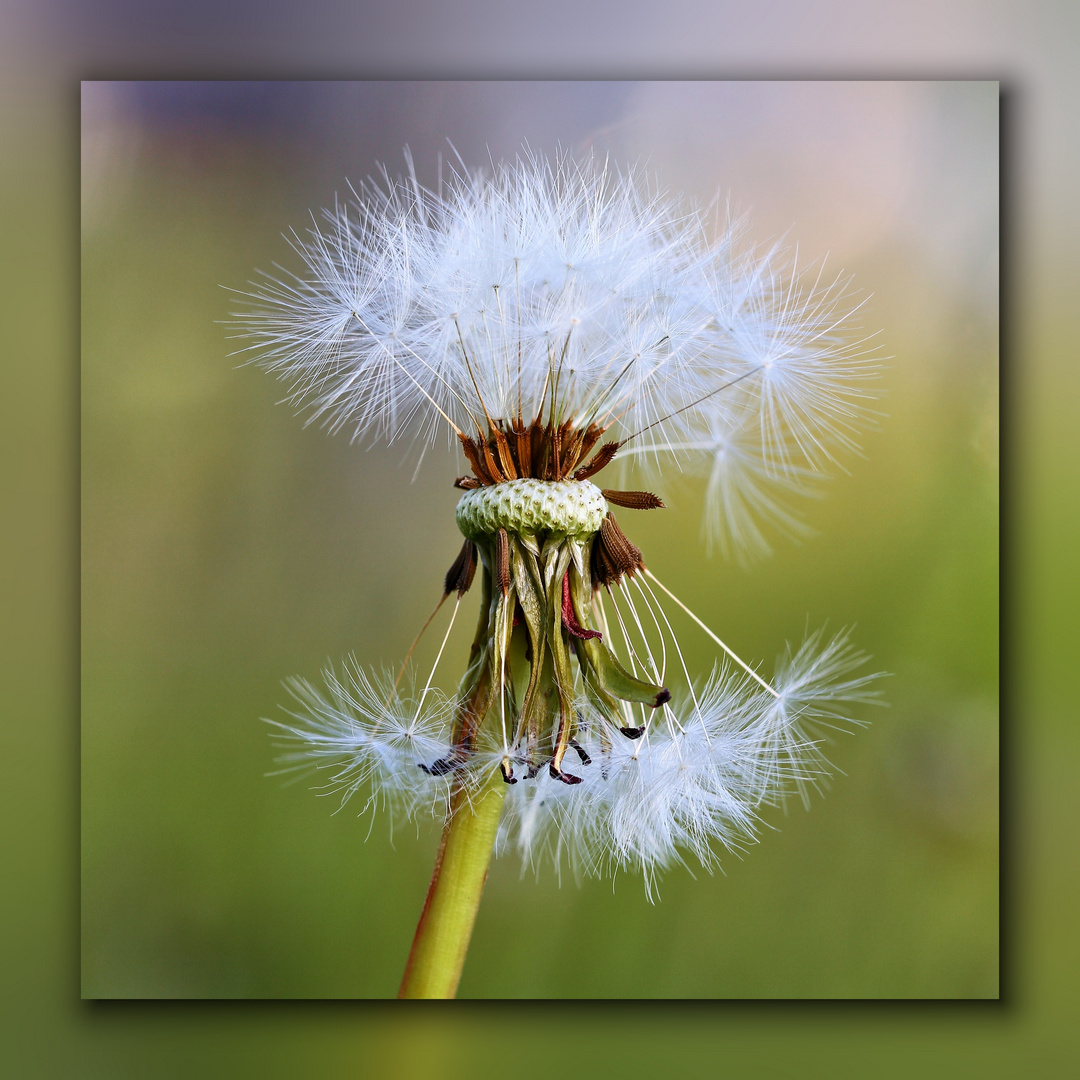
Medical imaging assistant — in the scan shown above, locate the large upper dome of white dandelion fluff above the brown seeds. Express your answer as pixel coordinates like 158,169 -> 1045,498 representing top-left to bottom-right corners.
233,154 -> 878,551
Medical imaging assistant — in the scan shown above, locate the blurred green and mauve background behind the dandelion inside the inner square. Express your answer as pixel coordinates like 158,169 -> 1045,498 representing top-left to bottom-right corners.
81,81 -> 1000,1000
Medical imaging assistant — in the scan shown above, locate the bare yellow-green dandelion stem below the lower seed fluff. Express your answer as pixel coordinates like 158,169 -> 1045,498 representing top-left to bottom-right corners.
397,770 -> 507,998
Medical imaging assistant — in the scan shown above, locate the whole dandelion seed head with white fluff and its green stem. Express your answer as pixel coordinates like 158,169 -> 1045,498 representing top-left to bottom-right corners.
235,147 -> 877,996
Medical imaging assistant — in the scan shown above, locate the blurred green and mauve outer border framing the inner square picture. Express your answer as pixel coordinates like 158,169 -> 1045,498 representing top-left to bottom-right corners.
12,0 -> 1080,1080
